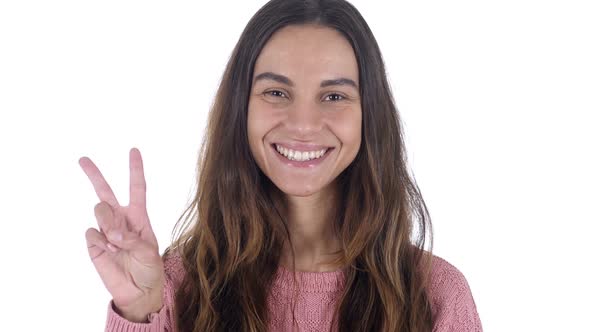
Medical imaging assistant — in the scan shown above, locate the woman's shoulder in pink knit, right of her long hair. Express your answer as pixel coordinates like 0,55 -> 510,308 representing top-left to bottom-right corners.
428,255 -> 482,332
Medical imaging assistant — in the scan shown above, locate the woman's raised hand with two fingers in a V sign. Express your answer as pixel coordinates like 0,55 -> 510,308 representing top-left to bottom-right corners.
79,148 -> 164,320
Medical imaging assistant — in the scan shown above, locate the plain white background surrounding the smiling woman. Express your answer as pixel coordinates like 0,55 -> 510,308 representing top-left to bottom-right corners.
0,0 -> 590,331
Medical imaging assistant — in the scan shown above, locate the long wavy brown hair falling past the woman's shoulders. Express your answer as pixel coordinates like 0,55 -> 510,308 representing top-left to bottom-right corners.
165,0 -> 432,332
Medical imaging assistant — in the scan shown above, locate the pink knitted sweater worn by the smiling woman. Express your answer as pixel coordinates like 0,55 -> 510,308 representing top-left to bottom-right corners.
105,256 -> 482,332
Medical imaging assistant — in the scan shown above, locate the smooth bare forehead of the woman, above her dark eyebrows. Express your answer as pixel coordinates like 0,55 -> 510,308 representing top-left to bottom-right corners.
254,25 -> 358,81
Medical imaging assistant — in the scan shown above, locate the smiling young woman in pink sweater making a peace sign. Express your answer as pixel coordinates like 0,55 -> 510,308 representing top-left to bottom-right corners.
80,0 -> 481,332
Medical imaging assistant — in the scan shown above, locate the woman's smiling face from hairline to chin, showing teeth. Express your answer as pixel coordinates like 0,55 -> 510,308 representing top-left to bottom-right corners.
248,25 -> 362,196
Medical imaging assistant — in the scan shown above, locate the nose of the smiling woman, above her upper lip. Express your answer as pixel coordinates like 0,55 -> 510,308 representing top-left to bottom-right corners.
285,101 -> 324,138
